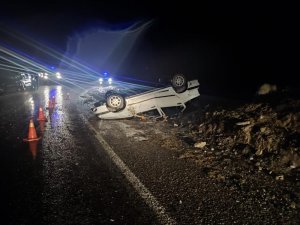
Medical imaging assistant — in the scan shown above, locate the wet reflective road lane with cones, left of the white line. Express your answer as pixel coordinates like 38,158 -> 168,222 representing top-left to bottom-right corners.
0,86 -> 157,225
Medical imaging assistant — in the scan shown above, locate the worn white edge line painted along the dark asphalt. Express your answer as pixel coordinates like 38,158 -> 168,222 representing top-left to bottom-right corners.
82,116 -> 177,225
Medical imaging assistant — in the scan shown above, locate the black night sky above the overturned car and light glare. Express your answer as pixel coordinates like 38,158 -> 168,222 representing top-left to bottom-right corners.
0,1 -> 299,97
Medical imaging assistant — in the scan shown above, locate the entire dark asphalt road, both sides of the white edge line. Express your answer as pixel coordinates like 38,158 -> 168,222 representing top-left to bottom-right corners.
0,83 -> 299,225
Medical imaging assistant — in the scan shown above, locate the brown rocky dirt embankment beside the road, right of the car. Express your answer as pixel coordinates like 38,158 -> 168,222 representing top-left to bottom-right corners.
156,94 -> 300,210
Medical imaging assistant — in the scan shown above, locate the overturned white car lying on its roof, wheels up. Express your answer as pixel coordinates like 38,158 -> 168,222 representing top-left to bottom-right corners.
91,74 -> 200,119
